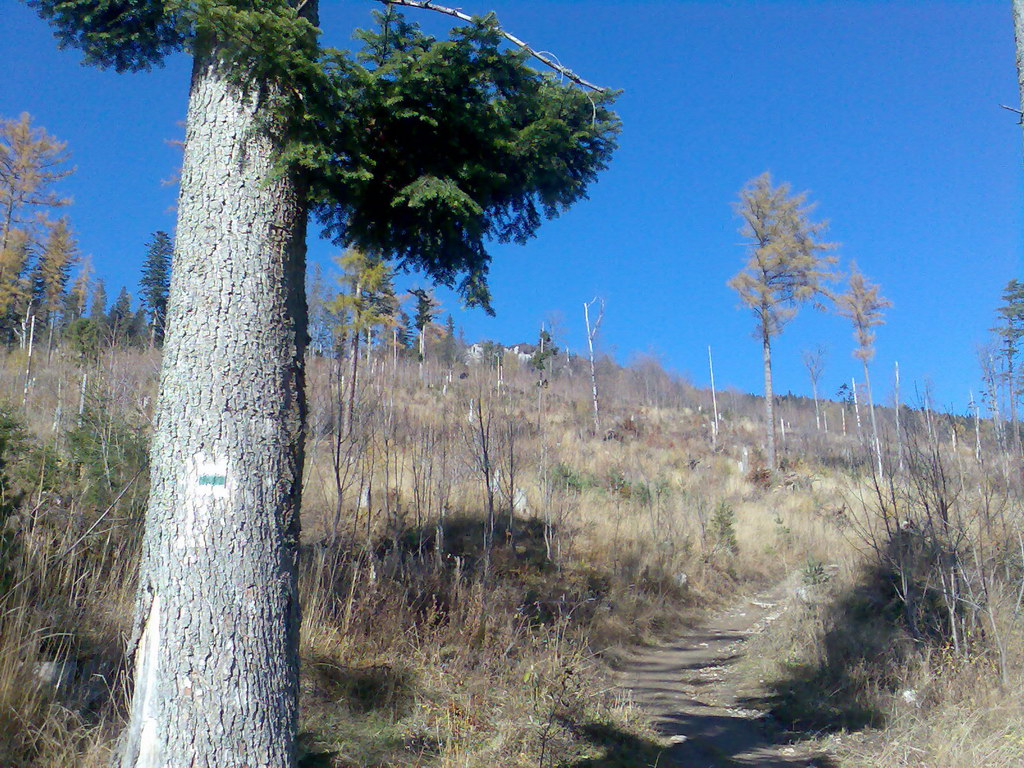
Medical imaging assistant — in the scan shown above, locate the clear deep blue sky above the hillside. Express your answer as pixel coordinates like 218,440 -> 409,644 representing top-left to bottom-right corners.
0,0 -> 1024,410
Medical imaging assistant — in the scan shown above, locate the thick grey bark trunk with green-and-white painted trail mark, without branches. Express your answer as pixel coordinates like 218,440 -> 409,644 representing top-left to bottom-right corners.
120,41 -> 306,768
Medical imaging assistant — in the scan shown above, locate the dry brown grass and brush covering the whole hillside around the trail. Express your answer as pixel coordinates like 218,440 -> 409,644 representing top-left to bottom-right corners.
0,350 -> 1024,768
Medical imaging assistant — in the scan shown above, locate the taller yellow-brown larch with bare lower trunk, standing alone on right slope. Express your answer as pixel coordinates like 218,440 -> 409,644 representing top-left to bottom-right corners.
729,172 -> 836,471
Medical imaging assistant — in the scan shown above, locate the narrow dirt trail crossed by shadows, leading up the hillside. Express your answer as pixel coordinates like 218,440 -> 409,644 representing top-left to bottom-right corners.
620,584 -> 833,768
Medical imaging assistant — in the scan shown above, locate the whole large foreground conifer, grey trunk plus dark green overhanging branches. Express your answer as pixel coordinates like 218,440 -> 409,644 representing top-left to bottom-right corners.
30,0 -> 617,768
